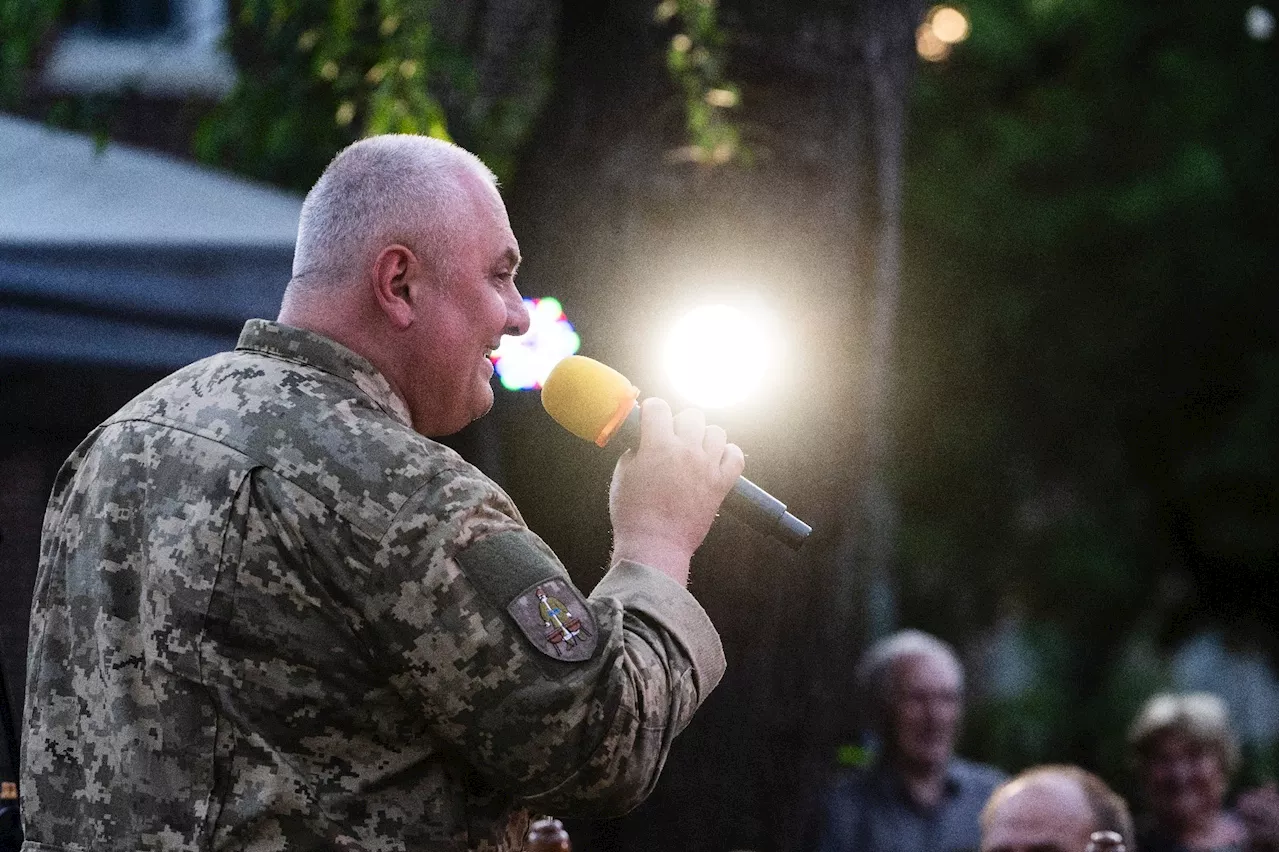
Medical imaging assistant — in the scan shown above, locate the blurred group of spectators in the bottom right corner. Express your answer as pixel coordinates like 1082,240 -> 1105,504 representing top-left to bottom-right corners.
795,629 -> 1280,852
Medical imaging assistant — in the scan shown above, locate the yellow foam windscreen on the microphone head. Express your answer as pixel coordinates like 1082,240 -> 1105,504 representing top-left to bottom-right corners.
543,356 -> 640,446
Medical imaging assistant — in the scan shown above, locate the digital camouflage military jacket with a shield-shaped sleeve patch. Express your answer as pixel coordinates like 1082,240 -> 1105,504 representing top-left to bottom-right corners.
22,320 -> 724,852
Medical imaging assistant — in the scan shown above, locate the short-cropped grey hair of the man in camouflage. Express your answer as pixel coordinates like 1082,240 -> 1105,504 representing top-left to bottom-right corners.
289,134 -> 498,289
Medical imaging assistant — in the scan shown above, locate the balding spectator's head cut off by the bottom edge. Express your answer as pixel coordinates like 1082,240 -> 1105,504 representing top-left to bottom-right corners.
982,765 -> 1134,852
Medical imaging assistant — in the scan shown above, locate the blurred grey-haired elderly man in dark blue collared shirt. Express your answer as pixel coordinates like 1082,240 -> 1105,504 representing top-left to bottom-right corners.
808,631 -> 1004,852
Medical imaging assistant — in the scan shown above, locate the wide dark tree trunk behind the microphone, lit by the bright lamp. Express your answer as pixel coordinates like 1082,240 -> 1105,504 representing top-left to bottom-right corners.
508,0 -> 918,852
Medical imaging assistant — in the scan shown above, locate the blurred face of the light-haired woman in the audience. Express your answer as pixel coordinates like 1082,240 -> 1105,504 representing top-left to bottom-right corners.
1142,730 -> 1228,828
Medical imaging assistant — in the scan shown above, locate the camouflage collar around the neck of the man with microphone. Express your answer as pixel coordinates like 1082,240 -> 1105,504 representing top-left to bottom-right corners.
236,320 -> 412,427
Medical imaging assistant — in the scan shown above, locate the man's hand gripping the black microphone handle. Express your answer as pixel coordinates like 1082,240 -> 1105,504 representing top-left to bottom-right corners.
609,398 -> 745,586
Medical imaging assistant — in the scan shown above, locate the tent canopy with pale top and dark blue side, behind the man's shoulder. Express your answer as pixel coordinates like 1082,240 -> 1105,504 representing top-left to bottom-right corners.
0,115 -> 301,368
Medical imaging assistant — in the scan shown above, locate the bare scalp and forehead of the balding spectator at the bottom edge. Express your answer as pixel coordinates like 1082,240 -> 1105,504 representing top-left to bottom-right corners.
982,775 -> 1094,852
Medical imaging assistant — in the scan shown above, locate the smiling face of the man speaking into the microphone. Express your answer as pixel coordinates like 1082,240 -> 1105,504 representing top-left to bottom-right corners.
410,175 -> 529,435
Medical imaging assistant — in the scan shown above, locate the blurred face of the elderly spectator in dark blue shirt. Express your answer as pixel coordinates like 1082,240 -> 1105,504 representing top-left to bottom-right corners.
890,654 -> 960,768
